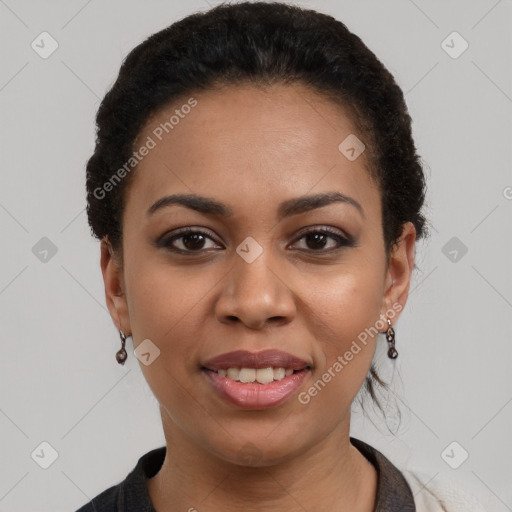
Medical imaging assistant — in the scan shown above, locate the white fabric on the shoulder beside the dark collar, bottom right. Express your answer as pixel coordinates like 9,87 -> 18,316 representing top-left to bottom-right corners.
402,470 -> 486,512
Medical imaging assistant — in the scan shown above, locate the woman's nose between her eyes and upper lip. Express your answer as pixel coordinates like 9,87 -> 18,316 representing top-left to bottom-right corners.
215,247 -> 296,330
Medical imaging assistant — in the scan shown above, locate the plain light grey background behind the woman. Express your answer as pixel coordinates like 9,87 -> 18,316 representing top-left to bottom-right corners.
0,0 -> 512,512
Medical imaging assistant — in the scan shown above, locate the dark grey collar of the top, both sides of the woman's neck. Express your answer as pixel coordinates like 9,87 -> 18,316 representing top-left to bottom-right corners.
76,437 -> 416,512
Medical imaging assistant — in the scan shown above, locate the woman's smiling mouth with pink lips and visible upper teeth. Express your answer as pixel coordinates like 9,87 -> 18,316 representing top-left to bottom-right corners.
201,350 -> 311,409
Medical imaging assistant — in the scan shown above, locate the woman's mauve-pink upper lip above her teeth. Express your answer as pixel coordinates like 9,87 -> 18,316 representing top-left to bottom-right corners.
202,349 -> 309,371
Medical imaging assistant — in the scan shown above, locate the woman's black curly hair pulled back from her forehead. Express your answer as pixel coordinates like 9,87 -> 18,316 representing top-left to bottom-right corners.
86,2 -> 426,416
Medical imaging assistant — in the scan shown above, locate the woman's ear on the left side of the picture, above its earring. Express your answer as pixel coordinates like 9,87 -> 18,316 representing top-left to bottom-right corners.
100,236 -> 131,336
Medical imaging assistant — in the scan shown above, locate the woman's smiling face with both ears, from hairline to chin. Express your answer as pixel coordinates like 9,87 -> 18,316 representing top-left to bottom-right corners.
102,85 -> 414,465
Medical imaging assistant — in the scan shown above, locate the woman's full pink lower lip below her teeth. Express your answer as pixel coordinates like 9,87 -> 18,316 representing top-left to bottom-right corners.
203,369 -> 309,409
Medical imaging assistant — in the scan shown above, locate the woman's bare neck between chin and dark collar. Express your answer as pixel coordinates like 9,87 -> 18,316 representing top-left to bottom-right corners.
148,412 -> 377,512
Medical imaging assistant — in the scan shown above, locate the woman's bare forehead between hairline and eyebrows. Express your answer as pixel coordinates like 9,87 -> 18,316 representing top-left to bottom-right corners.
127,85 -> 378,219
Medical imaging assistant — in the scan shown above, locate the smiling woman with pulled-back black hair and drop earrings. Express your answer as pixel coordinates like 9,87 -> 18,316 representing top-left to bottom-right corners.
80,2 -> 486,512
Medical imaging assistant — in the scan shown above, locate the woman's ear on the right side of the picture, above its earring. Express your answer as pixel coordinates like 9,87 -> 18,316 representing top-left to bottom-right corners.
381,222 -> 416,323
